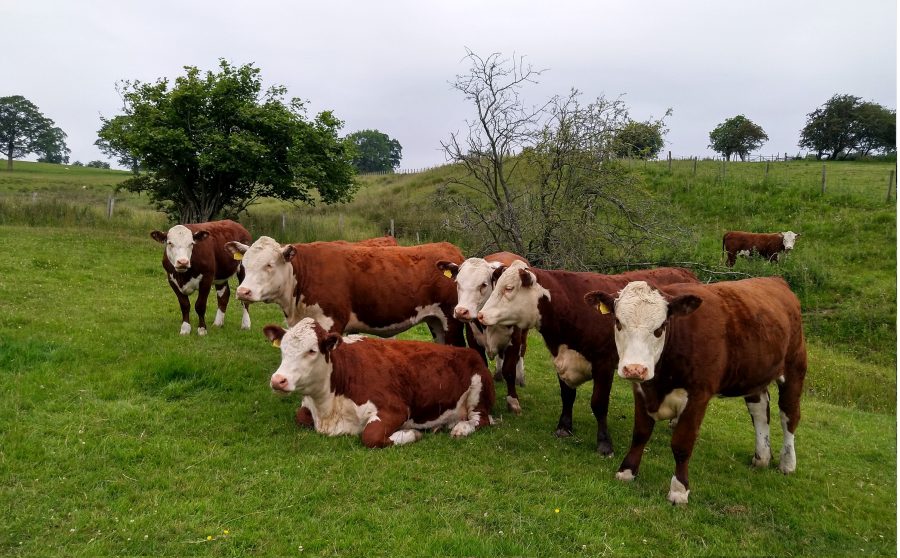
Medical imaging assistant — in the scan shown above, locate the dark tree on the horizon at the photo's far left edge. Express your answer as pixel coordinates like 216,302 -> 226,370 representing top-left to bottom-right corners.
0,95 -> 61,170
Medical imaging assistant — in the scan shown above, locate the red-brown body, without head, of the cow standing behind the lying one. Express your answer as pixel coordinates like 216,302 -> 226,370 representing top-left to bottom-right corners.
290,242 -> 464,344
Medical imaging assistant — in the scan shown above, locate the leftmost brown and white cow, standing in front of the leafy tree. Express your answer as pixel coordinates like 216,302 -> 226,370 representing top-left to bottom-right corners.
150,220 -> 251,335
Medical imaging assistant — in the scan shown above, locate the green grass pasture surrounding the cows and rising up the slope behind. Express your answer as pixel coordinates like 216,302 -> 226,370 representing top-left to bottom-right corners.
0,163 -> 897,556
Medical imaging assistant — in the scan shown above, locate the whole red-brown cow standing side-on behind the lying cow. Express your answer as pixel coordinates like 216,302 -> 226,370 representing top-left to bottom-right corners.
228,236 -> 465,346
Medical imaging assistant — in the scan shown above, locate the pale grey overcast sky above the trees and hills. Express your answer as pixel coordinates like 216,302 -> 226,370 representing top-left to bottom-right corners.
0,0 -> 897,168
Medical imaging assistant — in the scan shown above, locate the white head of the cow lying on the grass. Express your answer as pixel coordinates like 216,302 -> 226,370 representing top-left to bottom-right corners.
263,318 -> 341,395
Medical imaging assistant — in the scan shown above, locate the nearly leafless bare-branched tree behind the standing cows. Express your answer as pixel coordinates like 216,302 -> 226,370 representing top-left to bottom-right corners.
437,51 -> 680,269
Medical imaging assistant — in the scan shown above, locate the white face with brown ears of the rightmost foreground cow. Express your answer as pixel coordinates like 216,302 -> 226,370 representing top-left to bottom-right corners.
584,281 -> 702,382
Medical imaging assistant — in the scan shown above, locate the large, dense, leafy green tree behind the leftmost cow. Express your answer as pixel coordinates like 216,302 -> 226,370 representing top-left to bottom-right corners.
98,60 -> 356,223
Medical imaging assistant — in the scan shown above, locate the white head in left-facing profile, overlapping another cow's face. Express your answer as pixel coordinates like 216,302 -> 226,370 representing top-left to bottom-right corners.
478,261 -> 550,329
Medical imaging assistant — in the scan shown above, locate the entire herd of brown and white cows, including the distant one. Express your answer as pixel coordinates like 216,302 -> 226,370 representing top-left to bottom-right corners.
151,221 -> 806,504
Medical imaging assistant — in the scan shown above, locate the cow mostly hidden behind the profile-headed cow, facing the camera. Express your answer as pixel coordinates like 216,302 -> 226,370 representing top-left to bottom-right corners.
437,252 -> 528,415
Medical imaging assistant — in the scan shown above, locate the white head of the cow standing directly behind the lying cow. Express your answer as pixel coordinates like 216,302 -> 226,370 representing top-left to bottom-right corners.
225,236 -> 297,302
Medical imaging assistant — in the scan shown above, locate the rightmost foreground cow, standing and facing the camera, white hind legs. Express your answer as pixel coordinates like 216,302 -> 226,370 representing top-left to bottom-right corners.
585,277 -> 806,504
